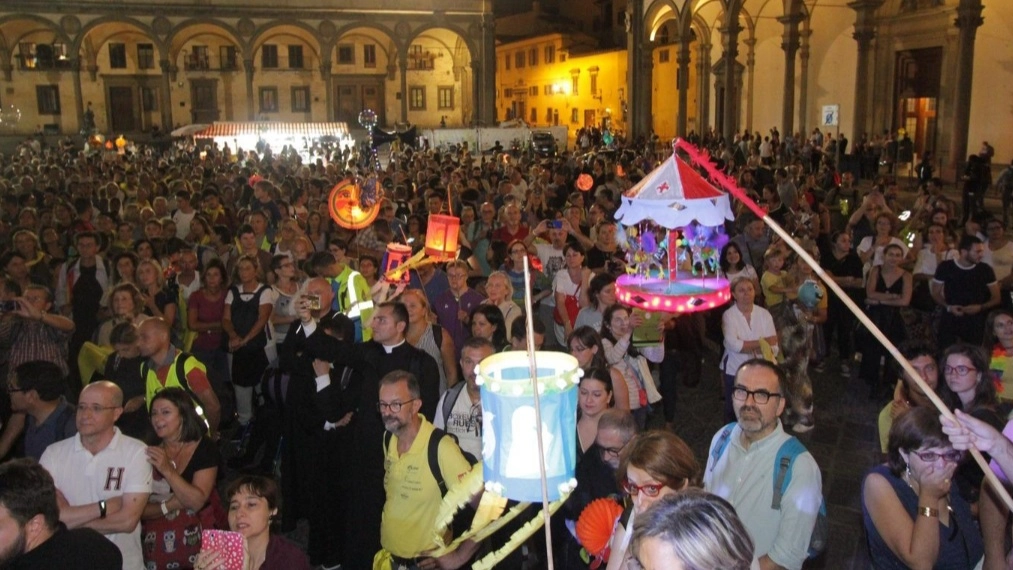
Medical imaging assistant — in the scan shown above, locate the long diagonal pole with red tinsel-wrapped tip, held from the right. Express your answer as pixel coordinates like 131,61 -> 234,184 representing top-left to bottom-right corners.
673,139 -> 1013,510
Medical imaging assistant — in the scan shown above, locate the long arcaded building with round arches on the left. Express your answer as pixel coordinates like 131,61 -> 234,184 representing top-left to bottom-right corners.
0,0 -> 495,134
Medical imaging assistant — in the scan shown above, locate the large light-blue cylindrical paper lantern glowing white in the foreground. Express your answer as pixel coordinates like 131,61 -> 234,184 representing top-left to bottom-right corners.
478,351 -> 582,502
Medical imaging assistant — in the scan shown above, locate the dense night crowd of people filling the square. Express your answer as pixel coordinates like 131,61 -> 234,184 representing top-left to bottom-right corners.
0,129 -> 1013,570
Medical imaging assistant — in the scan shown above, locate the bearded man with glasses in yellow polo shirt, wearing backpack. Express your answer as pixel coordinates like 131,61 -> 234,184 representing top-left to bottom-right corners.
374,371 -> 477,570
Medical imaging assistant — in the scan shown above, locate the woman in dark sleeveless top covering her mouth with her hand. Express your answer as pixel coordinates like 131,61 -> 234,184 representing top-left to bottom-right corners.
862,407 -> 984,570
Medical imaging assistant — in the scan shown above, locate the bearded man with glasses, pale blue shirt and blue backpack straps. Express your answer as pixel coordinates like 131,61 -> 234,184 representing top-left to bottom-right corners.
703,358 -> 823,570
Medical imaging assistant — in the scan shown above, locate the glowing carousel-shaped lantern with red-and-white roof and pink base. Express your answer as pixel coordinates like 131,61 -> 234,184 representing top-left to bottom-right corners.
616,146 -> 733,313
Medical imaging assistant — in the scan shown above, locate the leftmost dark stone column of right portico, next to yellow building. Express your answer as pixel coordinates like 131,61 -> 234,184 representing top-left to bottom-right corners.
626,0 -> 653,139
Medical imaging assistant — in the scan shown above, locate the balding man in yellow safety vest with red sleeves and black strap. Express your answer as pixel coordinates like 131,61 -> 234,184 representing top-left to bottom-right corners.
137,317 -> 222,434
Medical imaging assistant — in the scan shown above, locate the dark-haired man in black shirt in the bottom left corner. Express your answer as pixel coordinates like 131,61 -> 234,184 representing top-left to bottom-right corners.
0,459 -> 123,570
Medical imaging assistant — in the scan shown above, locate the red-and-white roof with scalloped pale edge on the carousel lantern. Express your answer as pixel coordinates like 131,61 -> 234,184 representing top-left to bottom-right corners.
616,154 -> 734,229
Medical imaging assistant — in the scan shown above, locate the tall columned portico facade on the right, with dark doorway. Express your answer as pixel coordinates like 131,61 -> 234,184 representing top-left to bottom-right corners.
496,0 -> 1013,179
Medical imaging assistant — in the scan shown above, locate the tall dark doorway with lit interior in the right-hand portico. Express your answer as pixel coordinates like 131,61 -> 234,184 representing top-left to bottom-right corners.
893,47 -> 943,160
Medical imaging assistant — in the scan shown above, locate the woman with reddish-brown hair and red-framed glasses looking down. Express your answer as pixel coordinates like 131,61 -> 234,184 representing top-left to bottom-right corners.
607,430 -> 700,570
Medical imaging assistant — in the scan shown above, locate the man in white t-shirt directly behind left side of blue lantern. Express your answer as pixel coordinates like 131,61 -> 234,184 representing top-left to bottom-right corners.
433,336 -> 496,460
